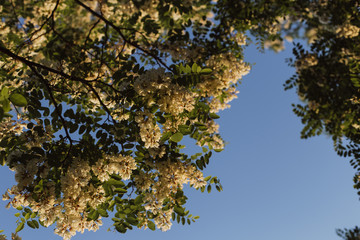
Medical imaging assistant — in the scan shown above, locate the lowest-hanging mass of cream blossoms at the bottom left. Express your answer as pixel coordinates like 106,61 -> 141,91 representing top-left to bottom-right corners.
3,155 -> 136,239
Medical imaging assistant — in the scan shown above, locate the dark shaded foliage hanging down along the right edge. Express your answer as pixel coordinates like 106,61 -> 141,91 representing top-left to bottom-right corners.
285,1 -> 360,194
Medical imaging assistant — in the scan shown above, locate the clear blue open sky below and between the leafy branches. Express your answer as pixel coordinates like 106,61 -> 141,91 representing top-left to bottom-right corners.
0,40 -> 360,240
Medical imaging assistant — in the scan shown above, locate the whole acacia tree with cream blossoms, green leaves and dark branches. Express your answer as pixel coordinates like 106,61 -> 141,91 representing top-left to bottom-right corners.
0,0 -> 360,239
